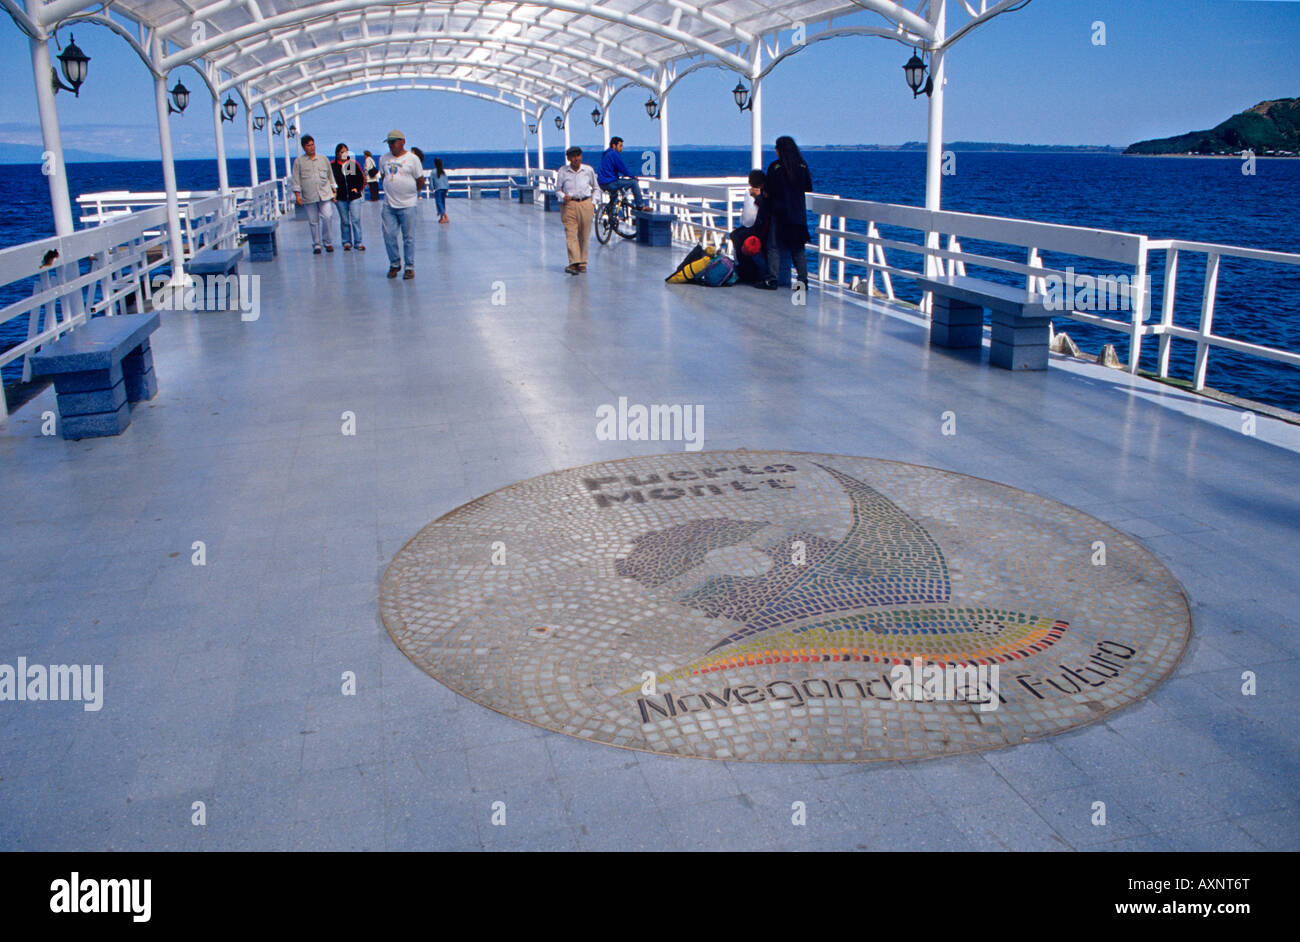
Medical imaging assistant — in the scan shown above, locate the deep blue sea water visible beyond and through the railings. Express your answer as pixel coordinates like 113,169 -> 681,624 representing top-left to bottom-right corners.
0,146 -> 1300,411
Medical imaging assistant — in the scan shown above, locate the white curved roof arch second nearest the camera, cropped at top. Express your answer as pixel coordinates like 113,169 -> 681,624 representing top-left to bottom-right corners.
159,0 -> 754,76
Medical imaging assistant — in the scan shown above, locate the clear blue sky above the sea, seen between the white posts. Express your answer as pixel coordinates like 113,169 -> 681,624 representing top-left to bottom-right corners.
0,0 -> 1300,159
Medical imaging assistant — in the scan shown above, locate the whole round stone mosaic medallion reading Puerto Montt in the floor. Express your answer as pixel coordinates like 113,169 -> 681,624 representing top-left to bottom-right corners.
380,451 -> 1191,761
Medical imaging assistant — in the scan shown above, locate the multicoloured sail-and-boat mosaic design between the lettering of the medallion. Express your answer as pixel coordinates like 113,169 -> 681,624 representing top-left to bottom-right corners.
615,464 -> 1069,680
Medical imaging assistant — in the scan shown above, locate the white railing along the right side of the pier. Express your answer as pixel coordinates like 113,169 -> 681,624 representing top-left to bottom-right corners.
618,178 -> 1300,390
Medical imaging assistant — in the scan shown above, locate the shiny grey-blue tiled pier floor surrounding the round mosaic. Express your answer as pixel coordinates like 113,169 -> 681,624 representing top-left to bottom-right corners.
0,200 -> 1300,850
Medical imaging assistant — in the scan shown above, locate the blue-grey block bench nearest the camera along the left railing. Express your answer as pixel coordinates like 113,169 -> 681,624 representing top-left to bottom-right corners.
29,313 -> 160,439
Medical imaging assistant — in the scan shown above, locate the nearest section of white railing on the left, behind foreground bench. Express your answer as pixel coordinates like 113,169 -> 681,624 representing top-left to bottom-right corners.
0,207 -> 172,418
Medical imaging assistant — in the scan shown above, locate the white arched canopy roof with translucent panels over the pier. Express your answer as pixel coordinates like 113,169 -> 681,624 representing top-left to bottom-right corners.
10,0 -> 1021,113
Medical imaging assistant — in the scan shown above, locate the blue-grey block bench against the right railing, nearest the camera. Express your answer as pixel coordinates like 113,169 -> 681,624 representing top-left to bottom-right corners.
917,275 -> 1052,370
